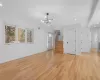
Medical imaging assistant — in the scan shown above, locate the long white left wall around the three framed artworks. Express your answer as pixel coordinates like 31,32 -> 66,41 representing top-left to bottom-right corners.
0,17 -> 52,63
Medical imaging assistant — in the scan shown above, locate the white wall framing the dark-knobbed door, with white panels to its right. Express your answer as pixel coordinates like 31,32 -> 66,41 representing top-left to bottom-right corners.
63,24 -> 91,55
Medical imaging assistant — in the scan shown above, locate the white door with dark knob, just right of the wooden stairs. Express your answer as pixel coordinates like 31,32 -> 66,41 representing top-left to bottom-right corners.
66,29 -> 76,54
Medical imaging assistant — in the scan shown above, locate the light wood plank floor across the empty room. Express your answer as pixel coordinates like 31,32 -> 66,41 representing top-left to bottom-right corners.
0,51 -> 100,80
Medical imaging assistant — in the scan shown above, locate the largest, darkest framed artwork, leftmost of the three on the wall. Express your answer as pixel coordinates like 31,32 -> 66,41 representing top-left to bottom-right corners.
5,25 -> 16,43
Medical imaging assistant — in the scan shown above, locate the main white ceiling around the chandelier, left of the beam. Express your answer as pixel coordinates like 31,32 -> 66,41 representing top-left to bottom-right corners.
0,0 -> 92,27
